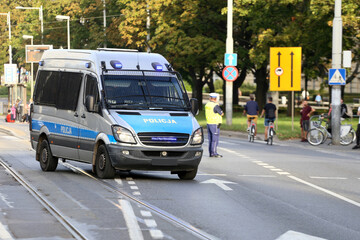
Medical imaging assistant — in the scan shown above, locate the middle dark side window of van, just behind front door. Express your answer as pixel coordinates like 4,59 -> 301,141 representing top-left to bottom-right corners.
56,72 -> 83,111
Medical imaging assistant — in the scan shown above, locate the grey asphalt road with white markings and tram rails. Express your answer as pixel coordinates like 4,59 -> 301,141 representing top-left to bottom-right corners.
0,119 -> 360,240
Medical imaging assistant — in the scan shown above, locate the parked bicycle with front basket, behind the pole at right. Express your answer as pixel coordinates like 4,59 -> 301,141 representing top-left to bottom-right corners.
306,115 -> 355,146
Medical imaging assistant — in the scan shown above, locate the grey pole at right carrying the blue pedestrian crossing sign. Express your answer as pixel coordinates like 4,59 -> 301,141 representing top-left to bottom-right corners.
329,0 -> 342,145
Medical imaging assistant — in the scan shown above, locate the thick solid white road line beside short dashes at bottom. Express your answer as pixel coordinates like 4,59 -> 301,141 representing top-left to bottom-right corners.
119,199 -> 144,240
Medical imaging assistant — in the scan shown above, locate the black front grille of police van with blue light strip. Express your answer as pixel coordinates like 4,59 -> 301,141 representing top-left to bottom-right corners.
138,133 -> 189,146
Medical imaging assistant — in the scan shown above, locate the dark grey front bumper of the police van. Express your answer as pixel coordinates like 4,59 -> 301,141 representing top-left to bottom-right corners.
107,144 -> 203,171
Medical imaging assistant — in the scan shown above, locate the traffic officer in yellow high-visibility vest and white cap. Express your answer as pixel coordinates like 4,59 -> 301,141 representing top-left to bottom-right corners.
205,93 -> 224,157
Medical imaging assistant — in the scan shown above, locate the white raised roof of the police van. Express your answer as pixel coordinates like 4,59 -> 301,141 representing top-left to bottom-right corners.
40,48 -> 169,71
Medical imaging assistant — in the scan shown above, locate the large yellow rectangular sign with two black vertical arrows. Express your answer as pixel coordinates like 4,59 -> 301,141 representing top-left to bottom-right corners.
270,47 -> 301,91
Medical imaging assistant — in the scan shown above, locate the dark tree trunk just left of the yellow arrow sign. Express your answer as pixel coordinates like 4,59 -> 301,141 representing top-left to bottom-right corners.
255,66 -> 269,110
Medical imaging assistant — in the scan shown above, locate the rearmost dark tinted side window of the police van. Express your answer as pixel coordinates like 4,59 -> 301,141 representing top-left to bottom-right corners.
34,71 -> 60,105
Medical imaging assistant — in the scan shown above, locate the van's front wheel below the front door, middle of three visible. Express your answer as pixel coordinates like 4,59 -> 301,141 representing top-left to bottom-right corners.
95,145 -> 115,179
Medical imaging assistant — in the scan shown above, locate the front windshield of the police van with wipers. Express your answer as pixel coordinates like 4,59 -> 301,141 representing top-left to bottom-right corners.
104,72 -> 189,111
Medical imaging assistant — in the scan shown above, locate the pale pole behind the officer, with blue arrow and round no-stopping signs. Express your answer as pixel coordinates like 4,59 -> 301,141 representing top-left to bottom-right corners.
225,0 -> 234,126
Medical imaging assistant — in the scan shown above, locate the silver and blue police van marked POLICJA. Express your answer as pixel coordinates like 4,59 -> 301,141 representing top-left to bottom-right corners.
30,49 -> 203,180
